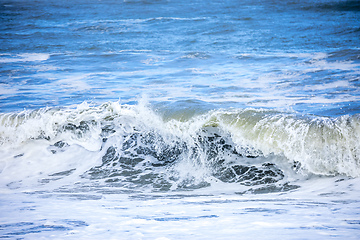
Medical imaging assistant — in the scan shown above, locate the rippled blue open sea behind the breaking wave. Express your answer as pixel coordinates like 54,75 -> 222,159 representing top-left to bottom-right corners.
0,0 -> 360,116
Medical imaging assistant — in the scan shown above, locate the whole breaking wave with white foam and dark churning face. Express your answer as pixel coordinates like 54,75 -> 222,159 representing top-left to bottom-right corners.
0,102 -> 360,193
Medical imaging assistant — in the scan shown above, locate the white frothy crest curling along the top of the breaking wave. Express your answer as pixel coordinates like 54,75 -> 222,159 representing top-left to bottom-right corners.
0,102 -> 360,182
